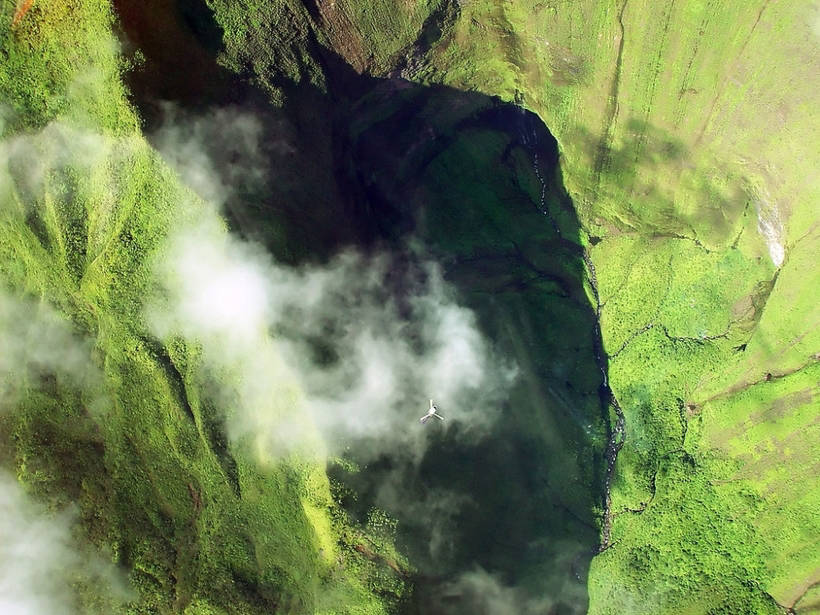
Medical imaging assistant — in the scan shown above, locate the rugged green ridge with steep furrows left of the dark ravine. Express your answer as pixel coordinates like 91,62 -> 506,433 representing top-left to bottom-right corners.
0,0 -> 402,615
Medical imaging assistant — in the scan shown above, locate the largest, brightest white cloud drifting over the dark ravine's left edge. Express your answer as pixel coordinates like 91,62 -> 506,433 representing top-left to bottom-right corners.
147,217 -> 514,456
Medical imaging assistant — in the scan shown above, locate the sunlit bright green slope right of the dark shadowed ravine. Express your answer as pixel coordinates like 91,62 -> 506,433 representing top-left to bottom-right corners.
195,0 -> 820,612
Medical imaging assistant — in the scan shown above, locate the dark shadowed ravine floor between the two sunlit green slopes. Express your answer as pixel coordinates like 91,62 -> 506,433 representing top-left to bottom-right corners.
107,0 -> 608,613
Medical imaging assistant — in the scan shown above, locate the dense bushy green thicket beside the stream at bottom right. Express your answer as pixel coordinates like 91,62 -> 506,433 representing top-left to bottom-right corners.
590,451 -> 780,615
